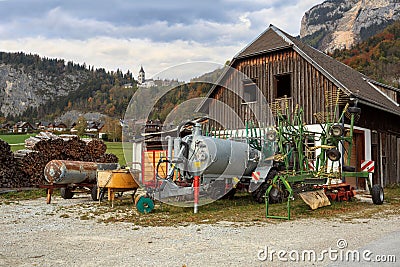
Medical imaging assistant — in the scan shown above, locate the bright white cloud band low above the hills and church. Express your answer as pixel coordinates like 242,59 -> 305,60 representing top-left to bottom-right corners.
0,37 -> 245,78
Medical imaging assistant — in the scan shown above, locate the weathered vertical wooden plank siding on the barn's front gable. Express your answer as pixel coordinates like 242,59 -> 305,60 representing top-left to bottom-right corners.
209,48 -> 346,128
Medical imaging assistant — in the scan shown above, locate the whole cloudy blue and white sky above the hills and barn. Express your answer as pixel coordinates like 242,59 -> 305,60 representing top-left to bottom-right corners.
0,0 -> 323,77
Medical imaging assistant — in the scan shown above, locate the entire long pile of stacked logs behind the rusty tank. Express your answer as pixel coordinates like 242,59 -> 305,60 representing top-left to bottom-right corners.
0,136 -> 118,187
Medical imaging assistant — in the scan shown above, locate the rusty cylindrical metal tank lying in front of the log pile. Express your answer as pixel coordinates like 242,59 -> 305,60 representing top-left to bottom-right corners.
44,160 -> 97,184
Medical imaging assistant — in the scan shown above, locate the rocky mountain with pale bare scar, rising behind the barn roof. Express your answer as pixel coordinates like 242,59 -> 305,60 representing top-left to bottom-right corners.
300,0 -> 400,52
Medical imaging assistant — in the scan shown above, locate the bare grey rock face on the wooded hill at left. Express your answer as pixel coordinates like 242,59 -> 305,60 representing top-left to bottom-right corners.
0,63 -> 88,116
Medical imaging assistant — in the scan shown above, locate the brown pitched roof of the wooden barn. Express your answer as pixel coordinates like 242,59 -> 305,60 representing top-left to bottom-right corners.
202,25 -> 400,116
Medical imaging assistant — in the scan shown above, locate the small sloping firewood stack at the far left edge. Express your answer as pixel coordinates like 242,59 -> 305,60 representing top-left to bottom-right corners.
0,140 -> 29,188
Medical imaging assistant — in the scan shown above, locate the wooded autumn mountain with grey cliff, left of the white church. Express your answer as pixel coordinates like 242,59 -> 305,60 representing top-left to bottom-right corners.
0,52 -> 137,122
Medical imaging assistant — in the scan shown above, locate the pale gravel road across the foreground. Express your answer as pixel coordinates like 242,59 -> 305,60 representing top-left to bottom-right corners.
0,197 -> 400,267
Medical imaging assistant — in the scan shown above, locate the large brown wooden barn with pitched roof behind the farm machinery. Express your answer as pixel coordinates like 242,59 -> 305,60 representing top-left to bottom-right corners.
199,25 -> 400,188
